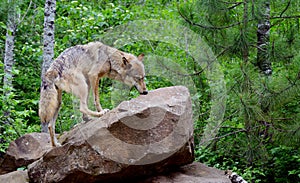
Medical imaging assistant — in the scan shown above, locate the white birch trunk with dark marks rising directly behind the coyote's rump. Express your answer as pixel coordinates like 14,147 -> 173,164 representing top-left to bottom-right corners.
41,0 -> 56,78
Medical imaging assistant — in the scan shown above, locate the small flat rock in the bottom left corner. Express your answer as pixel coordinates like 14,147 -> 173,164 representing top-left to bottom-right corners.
0,170 -> 29,183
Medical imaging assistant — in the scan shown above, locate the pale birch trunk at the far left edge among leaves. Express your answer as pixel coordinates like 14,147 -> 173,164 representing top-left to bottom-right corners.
3,0 -> 18,124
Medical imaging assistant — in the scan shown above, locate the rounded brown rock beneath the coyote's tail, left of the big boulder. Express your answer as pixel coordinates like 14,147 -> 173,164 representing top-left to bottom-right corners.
0,133 -> 51,175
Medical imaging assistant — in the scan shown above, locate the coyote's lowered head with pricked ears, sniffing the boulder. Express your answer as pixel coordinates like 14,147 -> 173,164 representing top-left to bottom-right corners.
122,54 -> 148,95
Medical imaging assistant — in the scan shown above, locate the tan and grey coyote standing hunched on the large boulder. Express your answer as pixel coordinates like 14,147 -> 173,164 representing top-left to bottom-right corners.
39,42 -> 148,147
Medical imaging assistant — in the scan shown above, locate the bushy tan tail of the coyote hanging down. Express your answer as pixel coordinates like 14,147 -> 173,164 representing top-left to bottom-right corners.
39,70 -> 60,132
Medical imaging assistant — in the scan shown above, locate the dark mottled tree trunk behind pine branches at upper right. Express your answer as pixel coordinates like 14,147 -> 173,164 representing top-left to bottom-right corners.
257,0 -> 272,75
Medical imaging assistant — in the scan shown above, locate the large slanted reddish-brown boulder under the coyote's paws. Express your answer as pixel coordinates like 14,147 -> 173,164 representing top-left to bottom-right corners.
28,86 -> 194,183
